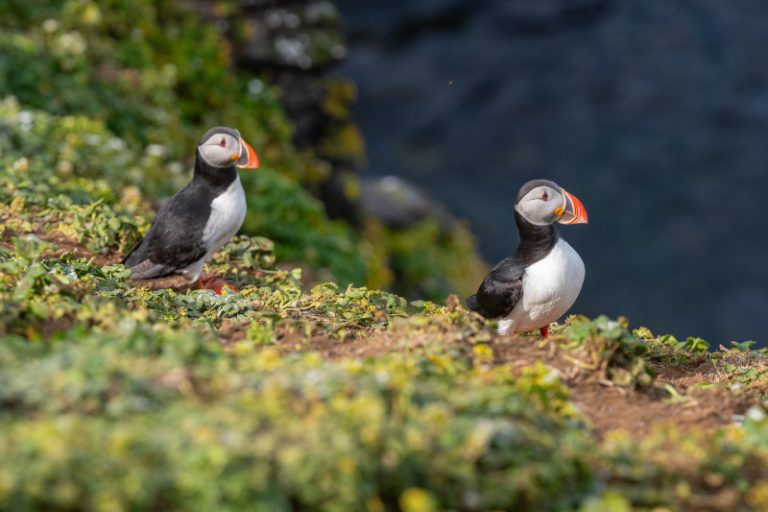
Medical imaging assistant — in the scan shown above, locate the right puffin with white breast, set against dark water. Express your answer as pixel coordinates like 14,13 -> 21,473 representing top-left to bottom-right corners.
466,180 -> 589,338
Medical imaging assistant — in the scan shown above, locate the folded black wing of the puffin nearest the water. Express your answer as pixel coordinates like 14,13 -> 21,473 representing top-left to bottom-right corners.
467,260 -> 525,318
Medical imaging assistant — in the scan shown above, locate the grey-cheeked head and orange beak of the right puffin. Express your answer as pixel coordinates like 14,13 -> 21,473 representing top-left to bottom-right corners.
515,180 -> 589,226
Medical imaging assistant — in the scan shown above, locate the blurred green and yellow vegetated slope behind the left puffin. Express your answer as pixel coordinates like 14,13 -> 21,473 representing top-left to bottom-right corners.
0,0 -> 483,298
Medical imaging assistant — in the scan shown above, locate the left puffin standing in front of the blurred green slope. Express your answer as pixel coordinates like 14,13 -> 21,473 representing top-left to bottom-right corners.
123,126 -> 259,294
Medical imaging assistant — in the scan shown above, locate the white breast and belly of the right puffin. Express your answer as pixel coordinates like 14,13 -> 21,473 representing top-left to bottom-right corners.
499,238 -> 585,332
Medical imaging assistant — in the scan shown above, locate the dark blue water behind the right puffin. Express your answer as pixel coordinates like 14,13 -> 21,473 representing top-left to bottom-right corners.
336,0 -> 768,345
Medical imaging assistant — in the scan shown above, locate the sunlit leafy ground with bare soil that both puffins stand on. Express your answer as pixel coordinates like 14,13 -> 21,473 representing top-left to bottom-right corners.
0,198 -> 768,511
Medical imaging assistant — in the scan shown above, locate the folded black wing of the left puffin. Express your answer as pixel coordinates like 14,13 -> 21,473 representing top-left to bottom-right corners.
123,187 -> 211,279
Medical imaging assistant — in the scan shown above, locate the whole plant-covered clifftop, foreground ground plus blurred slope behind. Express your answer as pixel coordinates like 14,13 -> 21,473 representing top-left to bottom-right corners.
0,0 -> 768,512
